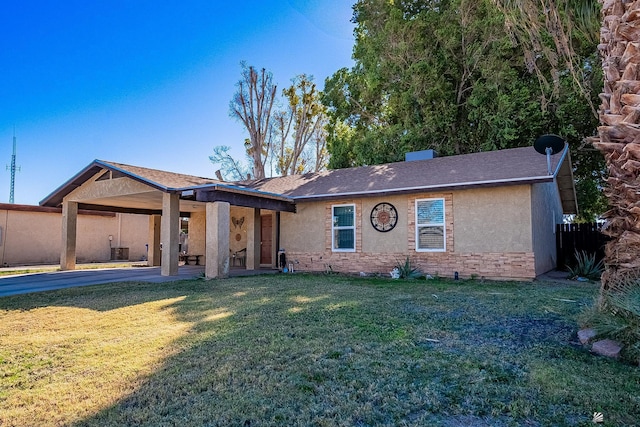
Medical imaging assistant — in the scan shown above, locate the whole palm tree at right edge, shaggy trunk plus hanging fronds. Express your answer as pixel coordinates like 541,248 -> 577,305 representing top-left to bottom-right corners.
493,0 -> 640,301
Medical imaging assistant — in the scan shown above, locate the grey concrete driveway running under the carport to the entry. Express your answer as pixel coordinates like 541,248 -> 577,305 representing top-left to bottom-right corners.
0,265 -> 277,297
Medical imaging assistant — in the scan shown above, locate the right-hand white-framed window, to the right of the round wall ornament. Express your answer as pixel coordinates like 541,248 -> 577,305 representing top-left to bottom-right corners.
416,199 -> 446,252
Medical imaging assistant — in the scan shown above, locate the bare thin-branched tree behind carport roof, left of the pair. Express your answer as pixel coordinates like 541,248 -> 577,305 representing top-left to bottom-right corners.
229,62 -> 277,179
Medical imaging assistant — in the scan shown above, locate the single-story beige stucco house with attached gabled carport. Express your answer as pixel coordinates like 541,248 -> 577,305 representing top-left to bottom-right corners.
41,145 -> 577,280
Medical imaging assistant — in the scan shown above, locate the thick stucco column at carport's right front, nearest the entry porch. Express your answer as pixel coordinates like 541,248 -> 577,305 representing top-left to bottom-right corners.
205,202 -> 231,279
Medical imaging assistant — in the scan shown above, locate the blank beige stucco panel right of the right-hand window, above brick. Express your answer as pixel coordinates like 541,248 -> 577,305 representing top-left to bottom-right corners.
453,185 -> 533,253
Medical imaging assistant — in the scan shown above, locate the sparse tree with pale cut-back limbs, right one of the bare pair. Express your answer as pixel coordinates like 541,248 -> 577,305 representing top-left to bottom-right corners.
275,74 -> 326,176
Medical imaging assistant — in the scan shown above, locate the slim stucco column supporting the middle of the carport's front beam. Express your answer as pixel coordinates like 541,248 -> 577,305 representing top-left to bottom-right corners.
160,193 -> 180,276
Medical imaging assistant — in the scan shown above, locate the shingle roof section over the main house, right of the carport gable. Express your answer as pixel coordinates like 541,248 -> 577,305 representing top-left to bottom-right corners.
250,147 -> 567,200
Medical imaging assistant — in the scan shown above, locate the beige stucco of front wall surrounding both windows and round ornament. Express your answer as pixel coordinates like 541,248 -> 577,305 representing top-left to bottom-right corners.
281,190 -> 533,254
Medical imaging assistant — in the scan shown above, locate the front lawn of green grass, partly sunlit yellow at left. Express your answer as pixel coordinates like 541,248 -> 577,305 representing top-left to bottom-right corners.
0,275 -> 640,427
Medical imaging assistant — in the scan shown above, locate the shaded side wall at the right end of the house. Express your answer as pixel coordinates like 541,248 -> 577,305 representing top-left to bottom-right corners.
531,182 -> 563,274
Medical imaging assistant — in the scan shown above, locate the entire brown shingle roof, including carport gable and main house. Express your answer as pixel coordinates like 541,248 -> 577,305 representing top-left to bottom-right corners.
40,146 -> 577,213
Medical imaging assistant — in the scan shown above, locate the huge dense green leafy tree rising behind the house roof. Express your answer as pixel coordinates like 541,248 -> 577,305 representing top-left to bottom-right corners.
323,0 -> 604,221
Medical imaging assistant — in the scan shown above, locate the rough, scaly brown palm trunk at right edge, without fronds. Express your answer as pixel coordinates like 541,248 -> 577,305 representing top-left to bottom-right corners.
594,0 -> 640,293
